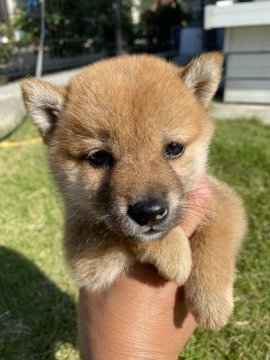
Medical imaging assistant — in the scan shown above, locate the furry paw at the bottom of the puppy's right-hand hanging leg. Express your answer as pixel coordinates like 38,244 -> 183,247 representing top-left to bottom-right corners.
185,288 -> 234,330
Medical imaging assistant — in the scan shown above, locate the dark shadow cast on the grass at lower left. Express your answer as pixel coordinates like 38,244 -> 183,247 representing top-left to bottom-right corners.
0,246 -> 76,360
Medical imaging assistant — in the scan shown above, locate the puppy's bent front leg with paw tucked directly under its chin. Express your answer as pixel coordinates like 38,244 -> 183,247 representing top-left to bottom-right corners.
133,226 -> 192,286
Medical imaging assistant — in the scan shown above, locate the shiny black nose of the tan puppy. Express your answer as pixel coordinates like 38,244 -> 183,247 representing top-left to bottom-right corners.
128,199 -> 168,226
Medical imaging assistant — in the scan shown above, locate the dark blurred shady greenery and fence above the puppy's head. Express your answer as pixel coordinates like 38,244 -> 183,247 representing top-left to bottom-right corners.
0,0 -> 223,82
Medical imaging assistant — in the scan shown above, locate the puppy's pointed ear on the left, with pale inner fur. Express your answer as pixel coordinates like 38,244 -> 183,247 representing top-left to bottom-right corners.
21,79 -> 66,138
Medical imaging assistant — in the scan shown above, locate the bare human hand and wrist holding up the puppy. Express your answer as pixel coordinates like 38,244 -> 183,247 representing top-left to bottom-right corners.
78,176 -> 211,360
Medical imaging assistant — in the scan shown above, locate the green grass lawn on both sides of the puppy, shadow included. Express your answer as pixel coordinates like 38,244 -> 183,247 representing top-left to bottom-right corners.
0,120 -> 270,360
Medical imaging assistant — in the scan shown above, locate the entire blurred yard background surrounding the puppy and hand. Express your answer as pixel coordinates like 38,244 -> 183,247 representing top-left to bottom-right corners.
0,0 -> 270,360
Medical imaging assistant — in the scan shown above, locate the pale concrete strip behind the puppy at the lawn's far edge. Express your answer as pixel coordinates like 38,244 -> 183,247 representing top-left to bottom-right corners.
0,67 -> 270,130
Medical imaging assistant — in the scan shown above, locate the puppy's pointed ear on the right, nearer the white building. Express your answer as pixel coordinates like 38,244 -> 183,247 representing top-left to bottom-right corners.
181,52 -> 223,107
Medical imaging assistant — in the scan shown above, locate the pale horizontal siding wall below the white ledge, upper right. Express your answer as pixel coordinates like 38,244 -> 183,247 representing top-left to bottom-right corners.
224,26 -> 270,104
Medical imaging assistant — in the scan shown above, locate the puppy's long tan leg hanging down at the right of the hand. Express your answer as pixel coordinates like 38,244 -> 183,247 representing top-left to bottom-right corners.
185,179 -> 246,329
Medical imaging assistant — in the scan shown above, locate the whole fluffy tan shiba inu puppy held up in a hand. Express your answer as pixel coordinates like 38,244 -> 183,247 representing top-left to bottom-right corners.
22,53 -> 246,329
